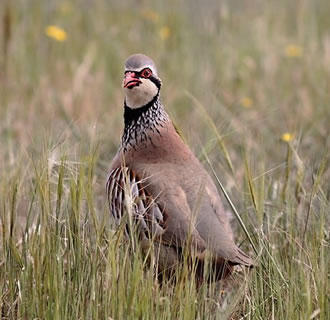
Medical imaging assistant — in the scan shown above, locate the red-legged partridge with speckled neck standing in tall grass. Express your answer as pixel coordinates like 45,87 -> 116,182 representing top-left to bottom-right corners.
106,53 -> 254,279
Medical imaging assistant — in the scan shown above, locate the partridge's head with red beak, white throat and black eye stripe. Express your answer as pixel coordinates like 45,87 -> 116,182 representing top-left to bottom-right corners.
123,54 -> 161,109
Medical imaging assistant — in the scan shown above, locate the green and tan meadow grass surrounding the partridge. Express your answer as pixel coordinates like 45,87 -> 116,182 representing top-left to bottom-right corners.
0,0 -> 330,320
